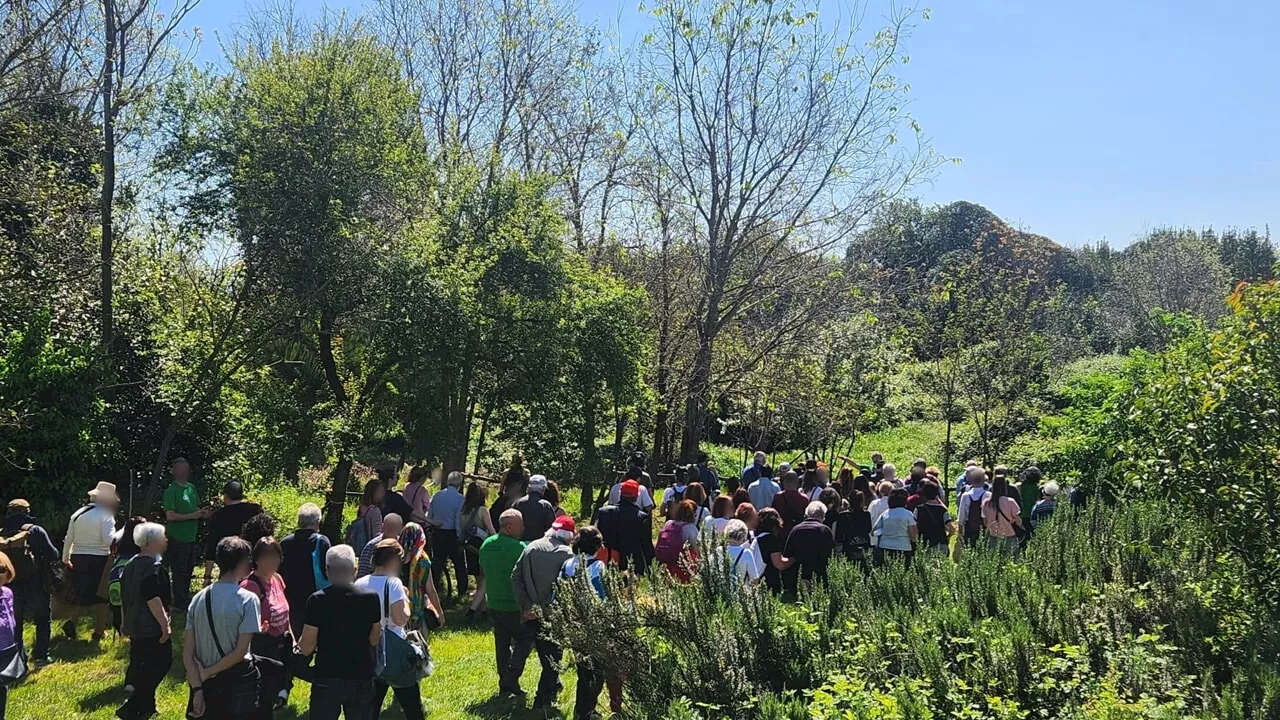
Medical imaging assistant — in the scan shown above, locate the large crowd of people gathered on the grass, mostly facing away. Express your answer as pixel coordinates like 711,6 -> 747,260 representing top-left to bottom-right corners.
0,452 -> 1062,720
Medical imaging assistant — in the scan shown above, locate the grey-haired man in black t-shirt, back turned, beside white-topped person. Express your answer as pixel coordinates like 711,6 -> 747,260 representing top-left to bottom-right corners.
298,544 -> 383,720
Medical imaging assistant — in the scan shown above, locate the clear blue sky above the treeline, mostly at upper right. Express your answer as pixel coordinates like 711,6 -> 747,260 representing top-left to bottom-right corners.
188,0 -> 1280,246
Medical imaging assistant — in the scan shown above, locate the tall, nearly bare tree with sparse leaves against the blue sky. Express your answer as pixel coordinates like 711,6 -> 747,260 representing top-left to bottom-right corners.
637,0 -> 934,459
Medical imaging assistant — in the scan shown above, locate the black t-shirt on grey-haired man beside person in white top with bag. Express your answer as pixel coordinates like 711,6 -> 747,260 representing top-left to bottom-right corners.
305,585 -> 383,680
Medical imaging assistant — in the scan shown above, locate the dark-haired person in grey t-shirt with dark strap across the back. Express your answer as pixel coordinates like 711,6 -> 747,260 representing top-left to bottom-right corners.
182,536 -> 263,720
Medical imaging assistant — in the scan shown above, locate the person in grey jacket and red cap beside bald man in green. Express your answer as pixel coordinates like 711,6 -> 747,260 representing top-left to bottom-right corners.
511,512 -> 576,710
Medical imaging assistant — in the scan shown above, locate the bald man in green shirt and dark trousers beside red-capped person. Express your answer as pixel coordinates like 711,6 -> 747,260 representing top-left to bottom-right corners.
480,509 -> 536,697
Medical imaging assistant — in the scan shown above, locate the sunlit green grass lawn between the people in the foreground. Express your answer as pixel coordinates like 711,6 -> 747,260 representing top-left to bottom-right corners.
8,594 -> 586,720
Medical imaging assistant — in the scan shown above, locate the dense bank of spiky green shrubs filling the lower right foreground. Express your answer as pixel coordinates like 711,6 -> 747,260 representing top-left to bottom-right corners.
549,503 -> 1280,719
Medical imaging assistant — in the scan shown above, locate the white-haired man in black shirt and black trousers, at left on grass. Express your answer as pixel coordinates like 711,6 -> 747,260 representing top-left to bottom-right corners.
115,523 -> 173,720
